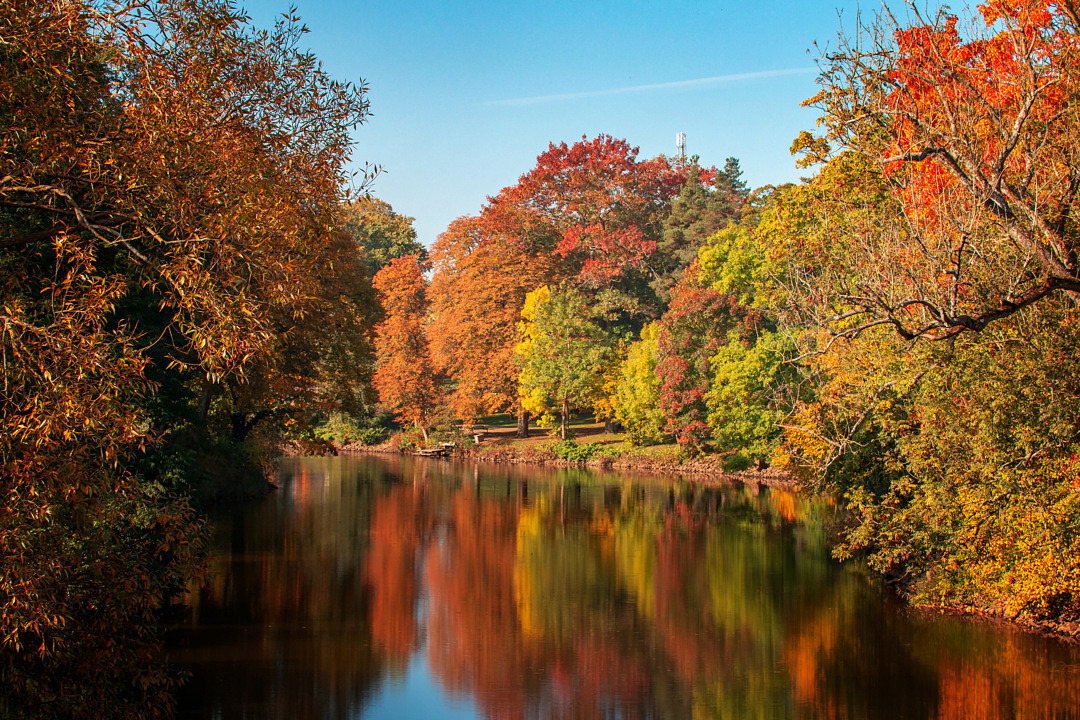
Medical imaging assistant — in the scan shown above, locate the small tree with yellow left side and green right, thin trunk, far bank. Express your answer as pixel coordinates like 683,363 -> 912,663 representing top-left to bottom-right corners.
516,286 -> 610,440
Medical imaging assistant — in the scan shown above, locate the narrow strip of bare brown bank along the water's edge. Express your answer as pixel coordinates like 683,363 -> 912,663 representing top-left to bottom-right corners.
308,443 -> 1080,644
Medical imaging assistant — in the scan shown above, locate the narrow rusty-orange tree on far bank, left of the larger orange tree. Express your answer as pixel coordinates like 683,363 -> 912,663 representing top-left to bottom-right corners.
372,255 -> 440,441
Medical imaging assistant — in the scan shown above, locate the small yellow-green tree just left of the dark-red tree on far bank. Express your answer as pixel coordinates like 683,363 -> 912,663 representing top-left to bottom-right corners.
613,323 -> 665,445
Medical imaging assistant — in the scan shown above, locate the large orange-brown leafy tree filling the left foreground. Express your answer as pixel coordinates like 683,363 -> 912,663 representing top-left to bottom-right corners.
0,0 -> 367,717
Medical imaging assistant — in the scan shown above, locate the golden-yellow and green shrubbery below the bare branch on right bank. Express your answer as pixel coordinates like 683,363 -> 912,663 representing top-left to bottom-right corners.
816,303 -> 1080,615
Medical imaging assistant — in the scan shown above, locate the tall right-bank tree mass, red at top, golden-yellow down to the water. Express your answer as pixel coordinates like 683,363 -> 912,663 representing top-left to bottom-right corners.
769,1 -> 1080,616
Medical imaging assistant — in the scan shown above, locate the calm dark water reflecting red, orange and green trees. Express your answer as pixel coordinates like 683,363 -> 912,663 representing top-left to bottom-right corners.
170,457 -> 1080,720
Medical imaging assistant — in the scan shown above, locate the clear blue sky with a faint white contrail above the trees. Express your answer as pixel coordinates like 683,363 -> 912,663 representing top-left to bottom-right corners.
244,0 -> 877,245
